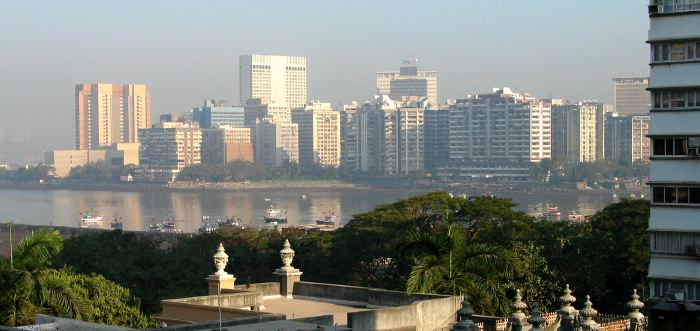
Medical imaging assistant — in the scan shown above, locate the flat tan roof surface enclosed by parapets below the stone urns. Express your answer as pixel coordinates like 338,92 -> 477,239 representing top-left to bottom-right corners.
261,298 -> 368,325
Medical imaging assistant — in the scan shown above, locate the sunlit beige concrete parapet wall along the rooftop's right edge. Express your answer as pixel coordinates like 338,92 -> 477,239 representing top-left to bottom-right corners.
348,296 -> 462,331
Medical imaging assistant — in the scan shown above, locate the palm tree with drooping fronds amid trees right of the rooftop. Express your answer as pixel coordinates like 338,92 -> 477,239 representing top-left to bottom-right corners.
404,212 -> 515,315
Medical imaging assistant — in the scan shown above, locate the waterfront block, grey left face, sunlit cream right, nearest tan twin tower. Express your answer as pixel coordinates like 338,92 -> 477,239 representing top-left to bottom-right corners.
139,122 -> 202,180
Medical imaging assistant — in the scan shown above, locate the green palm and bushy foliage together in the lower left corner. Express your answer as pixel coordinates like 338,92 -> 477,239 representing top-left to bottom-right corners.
0,229 -> 155,328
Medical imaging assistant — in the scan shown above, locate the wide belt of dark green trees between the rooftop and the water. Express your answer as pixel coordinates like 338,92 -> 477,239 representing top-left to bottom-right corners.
55,192 -> 649,315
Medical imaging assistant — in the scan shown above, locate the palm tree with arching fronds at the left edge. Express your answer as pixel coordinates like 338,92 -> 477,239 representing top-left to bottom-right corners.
0,229 -> 83,326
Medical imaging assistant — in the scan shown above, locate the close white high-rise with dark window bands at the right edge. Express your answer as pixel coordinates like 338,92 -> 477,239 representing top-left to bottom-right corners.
647,0 -> 700,300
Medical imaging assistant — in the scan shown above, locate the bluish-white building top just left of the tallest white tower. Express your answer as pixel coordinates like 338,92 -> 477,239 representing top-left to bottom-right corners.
192,99 -> 244,129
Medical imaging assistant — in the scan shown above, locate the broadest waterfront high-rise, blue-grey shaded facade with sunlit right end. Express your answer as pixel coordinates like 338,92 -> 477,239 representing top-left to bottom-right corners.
438,88 -> 549,181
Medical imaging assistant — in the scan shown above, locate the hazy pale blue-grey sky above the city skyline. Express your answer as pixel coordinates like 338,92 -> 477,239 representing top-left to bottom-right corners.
0,0 -> 649,163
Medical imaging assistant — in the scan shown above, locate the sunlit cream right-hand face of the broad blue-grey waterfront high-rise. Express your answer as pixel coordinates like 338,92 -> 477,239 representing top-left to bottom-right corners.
530,101 -> 552,162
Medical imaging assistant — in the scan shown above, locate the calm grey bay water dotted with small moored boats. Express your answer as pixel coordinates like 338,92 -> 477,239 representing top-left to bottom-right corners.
0,189 -> 615,232
